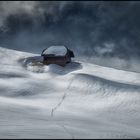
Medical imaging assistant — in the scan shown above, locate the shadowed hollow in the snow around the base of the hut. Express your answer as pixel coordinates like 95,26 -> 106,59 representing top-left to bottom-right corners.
20,56 -> 82,75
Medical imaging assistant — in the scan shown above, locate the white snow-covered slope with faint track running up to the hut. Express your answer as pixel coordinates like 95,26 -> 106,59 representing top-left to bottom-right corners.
0,47 -> 140,139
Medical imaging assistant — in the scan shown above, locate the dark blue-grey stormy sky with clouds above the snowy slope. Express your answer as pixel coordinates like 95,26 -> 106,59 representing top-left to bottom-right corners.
0,1 -> 140,59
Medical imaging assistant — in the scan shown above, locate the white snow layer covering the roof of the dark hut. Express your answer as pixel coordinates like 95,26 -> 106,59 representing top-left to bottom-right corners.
43,46 -> 67,56
